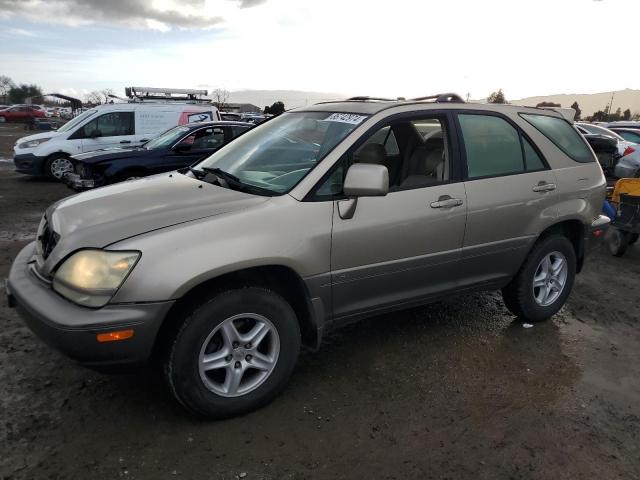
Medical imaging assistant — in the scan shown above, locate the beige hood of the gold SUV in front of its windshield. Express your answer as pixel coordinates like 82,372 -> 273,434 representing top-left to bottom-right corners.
43,172 -> 269,274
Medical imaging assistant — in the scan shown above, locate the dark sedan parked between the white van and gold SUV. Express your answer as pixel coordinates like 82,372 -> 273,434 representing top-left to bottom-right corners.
63,121 -> 254,191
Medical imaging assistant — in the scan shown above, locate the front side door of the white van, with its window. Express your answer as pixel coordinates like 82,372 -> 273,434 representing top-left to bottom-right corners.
78,111 -> 135,152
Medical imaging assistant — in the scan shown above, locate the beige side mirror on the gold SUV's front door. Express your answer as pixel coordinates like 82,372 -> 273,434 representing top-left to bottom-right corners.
338,163 -> 389,220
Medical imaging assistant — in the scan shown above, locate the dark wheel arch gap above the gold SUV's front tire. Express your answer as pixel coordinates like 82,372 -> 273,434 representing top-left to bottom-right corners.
149,265 -> 320,357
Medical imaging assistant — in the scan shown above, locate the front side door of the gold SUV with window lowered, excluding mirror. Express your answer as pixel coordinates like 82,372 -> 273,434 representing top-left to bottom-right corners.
328,114 -> 467,319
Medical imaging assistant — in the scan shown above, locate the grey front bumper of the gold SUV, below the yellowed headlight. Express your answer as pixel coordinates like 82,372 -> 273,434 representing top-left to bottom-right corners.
6,242 -> 173,367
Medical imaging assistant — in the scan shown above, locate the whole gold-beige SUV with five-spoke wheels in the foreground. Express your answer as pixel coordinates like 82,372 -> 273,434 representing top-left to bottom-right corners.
7,94 -> 609,418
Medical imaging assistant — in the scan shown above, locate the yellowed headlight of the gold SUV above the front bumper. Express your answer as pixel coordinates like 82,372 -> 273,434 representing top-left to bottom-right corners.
53,250 -> 140,307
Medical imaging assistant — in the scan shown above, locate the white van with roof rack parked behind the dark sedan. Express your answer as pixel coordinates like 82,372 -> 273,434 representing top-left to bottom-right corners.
13,102 -> 220,179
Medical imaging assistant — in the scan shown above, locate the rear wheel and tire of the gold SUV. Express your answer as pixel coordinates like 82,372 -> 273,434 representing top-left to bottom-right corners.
502,235 -> 576,323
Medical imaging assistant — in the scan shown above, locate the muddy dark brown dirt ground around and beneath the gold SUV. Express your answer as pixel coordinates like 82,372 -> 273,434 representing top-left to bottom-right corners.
0,126 -> 640,479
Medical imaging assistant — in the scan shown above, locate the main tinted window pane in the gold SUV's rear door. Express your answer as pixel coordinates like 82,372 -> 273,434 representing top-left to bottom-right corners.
458,114 -> 525,178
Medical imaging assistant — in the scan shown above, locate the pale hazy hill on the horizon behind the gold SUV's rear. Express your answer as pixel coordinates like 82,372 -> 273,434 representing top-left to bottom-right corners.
510,88 -> 640,117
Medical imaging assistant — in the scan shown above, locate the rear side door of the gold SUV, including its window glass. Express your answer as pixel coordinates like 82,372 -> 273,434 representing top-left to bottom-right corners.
457,111 -> 557,286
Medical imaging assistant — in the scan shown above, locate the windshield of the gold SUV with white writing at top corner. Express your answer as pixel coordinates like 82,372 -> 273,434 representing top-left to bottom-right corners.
195,112 -> 367,194
